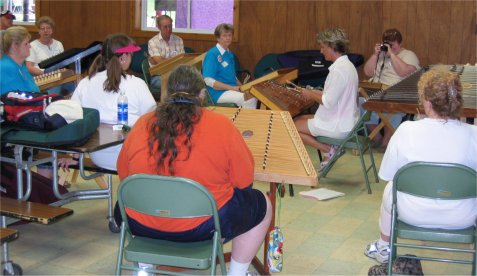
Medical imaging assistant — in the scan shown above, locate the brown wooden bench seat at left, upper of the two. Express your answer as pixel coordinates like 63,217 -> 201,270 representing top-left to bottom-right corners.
0,197 -> 73,224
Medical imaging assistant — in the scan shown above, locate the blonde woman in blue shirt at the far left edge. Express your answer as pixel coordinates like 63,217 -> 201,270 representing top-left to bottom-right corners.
0,26 -> 40,95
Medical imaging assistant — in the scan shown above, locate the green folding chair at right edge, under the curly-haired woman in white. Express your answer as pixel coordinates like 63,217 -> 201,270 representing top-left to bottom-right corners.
388,162 -> 477,275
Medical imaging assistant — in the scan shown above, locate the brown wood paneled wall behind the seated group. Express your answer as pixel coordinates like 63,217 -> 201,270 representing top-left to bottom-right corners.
37,0 -> 477,75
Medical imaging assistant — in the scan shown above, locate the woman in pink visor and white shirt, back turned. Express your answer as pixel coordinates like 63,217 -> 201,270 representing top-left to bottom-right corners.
59,33 -> 156,171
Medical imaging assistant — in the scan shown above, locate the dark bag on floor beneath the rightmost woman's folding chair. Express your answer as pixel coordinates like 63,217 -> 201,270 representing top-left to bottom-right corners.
368,254 -> 424,276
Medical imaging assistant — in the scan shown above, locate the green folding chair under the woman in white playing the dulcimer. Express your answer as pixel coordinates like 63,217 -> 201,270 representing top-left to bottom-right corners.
316,111 -> 379,194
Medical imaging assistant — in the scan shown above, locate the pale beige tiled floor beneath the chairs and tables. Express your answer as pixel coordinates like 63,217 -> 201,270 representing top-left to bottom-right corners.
3,147 -> 470,275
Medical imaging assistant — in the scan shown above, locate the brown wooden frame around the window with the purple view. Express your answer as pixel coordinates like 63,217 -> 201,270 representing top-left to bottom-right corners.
129,0 -> 240,42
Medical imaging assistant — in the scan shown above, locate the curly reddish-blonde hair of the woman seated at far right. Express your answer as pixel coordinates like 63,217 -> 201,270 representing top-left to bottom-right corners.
417,66 -> 463,119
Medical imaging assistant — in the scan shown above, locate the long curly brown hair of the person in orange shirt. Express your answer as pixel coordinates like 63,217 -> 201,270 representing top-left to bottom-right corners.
148,65 -> 205,175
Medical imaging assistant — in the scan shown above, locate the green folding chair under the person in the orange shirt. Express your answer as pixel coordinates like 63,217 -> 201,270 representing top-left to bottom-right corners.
116,174 -> 227,275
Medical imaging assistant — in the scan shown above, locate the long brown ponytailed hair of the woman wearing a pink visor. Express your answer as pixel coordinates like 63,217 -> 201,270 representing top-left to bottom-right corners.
88,33 -> 134,92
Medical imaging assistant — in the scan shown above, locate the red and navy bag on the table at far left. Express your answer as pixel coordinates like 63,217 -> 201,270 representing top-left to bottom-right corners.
1,91 -> 66,130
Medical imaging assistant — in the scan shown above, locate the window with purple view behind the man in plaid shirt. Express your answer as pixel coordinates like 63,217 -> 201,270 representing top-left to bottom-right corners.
141,0 -> 238,34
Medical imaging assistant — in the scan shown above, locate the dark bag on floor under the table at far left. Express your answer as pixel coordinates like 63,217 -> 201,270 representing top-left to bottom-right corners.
1,162 -> 68,204
